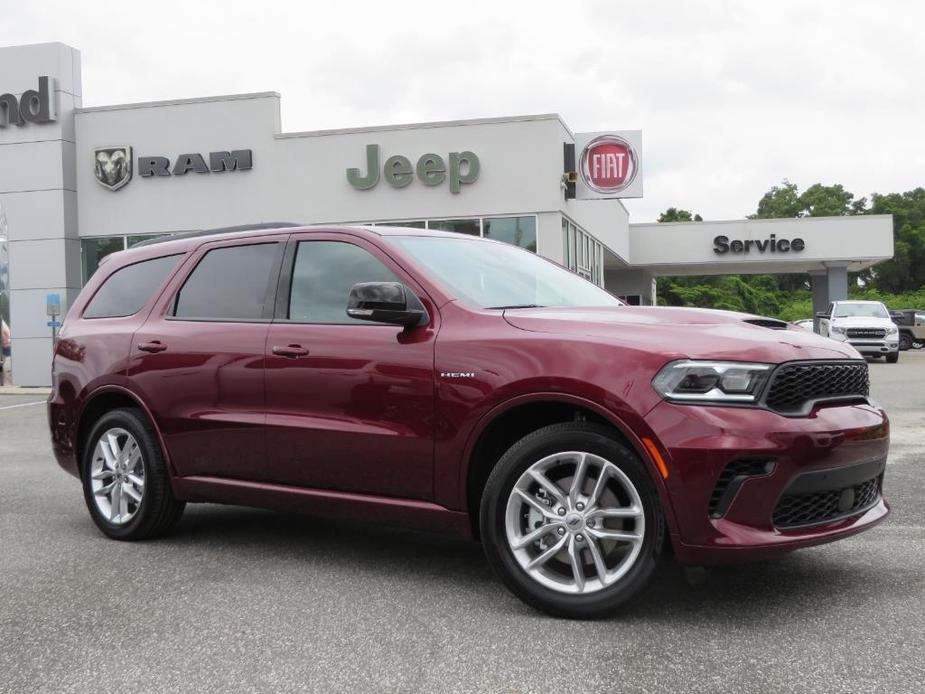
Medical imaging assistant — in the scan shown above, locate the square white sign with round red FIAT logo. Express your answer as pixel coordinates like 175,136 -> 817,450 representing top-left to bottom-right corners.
575,130 -> 642,200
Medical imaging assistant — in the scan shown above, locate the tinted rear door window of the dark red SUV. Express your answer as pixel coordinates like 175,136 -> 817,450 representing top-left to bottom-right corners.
173,242 -> 280,320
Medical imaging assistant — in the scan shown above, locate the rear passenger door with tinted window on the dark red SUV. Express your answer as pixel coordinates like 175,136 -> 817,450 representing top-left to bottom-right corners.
128,235 -> 286,479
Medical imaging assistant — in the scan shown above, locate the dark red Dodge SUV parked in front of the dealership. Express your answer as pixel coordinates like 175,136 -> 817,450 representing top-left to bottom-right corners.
48,227 -> 889,617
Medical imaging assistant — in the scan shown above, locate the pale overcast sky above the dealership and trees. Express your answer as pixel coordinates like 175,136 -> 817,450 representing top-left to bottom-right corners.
0,0 -> 925,222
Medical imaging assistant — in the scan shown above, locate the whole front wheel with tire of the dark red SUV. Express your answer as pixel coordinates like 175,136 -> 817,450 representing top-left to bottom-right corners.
480,422 -> 664,618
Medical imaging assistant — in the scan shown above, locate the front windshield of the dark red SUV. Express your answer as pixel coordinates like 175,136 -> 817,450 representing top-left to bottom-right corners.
396,236 -> 622,308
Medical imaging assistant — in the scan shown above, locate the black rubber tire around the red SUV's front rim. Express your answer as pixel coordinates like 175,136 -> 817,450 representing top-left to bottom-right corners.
480,422 -> 665,619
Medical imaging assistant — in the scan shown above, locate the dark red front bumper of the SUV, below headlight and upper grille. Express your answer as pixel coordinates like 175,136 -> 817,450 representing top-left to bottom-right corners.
646,402 -> 889,564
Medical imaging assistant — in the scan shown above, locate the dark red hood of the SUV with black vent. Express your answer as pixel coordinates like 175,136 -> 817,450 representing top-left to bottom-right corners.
504,306 -> 861,363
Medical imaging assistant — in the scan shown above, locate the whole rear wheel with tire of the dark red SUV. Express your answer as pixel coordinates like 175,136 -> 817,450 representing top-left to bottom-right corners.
81,408 -> 184,540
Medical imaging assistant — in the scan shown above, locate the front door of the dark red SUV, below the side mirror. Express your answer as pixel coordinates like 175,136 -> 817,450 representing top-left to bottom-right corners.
266,233 -> 437,499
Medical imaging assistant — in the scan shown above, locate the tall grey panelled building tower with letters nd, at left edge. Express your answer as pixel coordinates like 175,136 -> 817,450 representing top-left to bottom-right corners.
0,43 -> 81,386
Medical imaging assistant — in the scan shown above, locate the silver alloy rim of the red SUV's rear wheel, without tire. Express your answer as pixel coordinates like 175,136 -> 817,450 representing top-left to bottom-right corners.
90,427 -> 145,525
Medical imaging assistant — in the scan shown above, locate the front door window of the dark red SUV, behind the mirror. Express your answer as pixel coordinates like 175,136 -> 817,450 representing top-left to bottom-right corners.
288,241 -> 400,325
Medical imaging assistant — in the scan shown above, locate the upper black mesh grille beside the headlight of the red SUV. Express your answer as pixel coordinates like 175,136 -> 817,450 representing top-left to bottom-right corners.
765,362 -> 870,414
